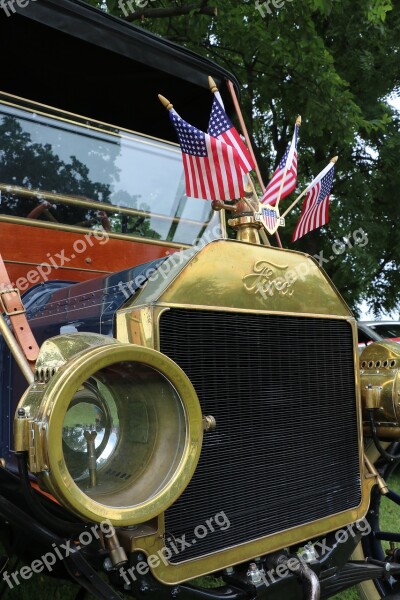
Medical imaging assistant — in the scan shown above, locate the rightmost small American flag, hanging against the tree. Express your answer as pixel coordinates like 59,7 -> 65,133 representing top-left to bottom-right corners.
292,162 -> 335,242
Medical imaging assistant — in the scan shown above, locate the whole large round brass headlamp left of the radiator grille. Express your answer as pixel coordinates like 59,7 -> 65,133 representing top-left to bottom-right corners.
14,333 -> 203,525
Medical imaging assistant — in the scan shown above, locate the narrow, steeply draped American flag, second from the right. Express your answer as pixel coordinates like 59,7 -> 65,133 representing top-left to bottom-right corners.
261,125 -> 299,206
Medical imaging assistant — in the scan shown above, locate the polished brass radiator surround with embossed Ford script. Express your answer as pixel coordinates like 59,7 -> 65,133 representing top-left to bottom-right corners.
117,240 -> 374,584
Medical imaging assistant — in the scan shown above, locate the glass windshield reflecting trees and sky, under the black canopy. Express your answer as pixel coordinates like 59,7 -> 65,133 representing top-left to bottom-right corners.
0,94 -> 218,245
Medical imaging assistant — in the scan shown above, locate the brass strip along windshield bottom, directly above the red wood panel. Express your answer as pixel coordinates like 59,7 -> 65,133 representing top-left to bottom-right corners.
0,216 -> 192,250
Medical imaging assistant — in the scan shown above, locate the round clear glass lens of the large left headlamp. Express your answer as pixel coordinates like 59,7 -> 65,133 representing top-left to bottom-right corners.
62,362 -> 187,508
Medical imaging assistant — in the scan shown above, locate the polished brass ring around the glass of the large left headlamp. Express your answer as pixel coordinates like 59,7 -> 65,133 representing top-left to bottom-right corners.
40,343 -> 203,526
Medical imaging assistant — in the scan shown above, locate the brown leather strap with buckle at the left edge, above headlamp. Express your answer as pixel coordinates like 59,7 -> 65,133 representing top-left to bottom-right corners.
0,254 -> 39,368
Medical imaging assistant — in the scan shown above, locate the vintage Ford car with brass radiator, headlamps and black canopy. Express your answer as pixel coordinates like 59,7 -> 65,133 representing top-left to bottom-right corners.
0,0 -> 400,600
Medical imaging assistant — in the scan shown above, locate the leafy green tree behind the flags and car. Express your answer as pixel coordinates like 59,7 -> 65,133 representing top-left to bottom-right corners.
85,0 -> 400,315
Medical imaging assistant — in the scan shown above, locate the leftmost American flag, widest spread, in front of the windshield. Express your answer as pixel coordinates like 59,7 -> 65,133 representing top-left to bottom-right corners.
169,109 -> 244,200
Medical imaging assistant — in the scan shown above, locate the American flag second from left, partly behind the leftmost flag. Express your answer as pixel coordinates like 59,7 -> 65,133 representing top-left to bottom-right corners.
208,92 -> 255,173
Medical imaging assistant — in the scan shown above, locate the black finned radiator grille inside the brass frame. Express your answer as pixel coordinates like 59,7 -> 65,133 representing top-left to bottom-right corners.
160,309 -> 361,563
